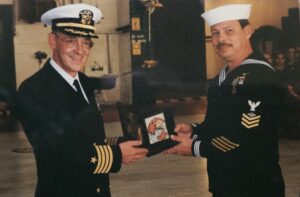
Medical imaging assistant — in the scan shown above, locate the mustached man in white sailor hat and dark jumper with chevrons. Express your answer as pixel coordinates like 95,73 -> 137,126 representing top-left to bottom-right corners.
168,4 -> 285,197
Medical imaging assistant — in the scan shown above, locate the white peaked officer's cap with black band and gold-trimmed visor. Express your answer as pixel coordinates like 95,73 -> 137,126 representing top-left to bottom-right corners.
41,3 -> 102,38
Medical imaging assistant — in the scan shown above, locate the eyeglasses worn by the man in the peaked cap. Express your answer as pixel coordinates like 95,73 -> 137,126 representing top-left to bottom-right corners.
53,33 -> 94,49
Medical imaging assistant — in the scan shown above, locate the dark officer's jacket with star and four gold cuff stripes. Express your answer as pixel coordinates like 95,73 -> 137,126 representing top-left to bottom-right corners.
17,61 -> 121,197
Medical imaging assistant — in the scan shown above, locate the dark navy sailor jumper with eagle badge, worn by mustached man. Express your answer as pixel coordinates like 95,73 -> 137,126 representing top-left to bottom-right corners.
193,54 -> 284,197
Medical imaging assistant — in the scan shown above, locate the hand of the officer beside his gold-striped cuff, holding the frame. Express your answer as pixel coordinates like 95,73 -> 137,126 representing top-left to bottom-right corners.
120,140 -> 148,164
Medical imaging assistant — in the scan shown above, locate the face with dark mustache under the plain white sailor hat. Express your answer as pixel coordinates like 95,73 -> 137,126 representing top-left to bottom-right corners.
211,20 -> 251,61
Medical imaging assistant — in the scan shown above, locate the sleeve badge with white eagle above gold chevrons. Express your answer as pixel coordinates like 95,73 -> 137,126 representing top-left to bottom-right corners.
241,100 -> 261,129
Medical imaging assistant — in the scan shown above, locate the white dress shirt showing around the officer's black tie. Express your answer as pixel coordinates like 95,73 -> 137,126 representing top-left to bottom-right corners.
50,59 -> 89,103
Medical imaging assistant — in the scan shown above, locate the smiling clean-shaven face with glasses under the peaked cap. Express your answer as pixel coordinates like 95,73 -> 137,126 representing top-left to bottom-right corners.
48,33 -> 92,77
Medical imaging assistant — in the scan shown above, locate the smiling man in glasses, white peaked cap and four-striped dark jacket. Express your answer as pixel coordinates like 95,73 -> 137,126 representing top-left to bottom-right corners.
17,4 -> 147,197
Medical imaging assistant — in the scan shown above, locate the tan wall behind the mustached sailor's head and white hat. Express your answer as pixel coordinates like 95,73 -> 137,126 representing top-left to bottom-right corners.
205,0 -> 299,79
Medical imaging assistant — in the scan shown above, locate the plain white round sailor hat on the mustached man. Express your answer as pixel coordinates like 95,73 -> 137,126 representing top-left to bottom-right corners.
201,4 -> 251,26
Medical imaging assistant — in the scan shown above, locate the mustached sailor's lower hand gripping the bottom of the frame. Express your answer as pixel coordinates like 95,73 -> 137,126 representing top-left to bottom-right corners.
165,135 -> 193,155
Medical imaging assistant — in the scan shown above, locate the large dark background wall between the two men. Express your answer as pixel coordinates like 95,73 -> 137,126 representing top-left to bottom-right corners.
130,0 -> 206,104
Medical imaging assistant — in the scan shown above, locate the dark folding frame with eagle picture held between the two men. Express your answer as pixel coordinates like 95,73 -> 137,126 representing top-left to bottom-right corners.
118,103 -> 178,156
